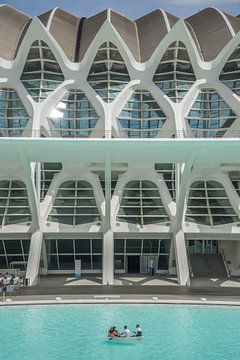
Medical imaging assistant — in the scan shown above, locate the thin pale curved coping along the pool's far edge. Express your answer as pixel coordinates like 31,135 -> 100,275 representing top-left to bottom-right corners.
0,296 -> 240,307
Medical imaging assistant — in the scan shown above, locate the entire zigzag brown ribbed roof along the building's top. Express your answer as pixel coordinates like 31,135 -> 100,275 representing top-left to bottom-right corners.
0,5 -> 240,62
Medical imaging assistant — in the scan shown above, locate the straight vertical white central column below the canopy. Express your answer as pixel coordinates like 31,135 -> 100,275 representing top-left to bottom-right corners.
102,151 -> 114,285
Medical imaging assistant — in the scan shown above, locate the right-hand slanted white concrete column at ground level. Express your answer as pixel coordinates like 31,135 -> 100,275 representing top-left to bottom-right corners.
173,230 -> 190,285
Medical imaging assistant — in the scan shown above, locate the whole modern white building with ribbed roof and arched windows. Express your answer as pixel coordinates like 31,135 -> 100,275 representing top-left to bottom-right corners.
0,5 -> 240,285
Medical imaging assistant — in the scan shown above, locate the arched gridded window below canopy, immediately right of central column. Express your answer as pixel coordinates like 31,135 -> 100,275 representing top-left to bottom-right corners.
117,181 -> 169,226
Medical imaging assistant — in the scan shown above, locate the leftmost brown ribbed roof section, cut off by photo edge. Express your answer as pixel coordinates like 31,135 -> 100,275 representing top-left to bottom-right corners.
0,5 -> 31,60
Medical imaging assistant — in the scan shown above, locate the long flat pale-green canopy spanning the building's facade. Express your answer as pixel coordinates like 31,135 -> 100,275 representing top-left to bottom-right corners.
0,138 -> 240,164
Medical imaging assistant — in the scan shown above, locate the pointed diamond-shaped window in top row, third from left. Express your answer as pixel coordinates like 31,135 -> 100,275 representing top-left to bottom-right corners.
153,41 -> 196,102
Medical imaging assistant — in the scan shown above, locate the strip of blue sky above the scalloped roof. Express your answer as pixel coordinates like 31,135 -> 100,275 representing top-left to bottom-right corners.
4,0 -> 240,20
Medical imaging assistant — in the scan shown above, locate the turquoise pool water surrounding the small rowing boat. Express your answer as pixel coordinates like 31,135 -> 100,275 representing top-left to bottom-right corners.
0,304 -> 240,360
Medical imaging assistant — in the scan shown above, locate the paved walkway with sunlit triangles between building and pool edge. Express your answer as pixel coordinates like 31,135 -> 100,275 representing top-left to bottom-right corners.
0,275 -> 240,302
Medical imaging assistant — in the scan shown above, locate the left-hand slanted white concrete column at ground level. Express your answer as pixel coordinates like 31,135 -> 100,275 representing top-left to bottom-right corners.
26,230 -> 43,286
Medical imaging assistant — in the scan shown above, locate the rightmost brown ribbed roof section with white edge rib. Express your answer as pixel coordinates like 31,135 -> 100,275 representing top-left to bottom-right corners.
185,8 -> 240,61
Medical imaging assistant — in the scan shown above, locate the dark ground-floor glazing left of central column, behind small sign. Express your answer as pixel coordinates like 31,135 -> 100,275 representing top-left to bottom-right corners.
46,239 -> 102,272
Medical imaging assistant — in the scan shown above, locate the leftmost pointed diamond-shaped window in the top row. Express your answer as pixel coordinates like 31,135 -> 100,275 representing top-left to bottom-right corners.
21,40 -> 64,102
